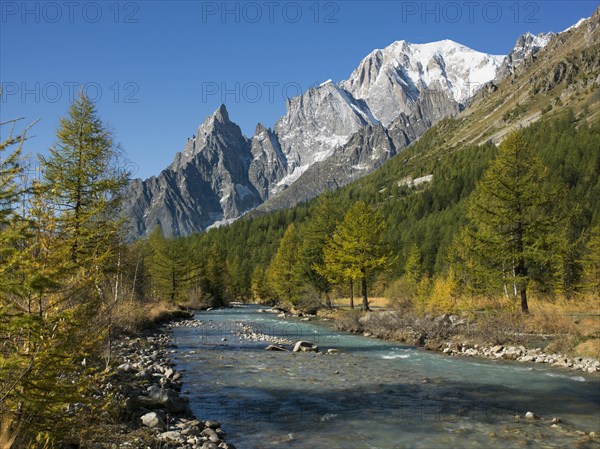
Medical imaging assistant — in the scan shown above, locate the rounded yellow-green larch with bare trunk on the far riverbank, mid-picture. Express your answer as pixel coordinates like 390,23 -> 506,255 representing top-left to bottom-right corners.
319,201 -> 392,310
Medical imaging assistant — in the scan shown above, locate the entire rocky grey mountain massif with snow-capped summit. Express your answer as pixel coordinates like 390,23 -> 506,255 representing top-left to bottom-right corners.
125,24 -> 572,239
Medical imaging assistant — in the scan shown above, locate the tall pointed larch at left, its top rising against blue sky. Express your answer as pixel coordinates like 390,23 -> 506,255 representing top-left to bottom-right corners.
40,93 -> 128,304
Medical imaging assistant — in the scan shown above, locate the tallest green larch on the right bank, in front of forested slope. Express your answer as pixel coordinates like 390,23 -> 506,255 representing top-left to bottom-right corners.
461,131 -> 557,313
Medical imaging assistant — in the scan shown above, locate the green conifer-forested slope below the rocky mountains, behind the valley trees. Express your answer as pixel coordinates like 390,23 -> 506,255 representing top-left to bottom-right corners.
138,112 -> 600,310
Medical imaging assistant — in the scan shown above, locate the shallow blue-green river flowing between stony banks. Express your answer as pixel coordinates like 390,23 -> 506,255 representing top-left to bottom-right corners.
172,306 -> 600,449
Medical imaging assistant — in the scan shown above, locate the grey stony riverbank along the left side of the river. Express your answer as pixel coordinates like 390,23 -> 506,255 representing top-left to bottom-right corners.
95,320 -> 235,449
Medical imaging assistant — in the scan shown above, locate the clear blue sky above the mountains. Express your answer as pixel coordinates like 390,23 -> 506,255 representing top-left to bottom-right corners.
0,0 -> 600,177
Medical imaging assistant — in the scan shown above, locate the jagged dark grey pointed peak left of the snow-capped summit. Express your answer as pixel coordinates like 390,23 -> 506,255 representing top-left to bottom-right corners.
125,106 -> 262,237
